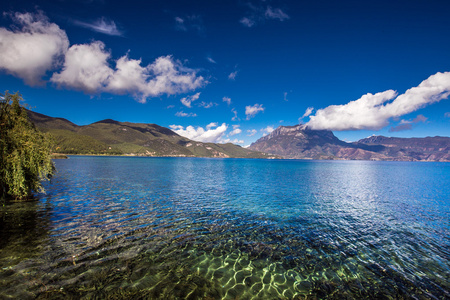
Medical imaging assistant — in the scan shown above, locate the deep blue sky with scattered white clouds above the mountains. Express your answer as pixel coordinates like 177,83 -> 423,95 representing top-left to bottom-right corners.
0,0 -> 450,146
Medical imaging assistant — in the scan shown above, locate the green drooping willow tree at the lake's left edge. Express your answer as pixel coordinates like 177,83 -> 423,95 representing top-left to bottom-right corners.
0,91 -> 54,201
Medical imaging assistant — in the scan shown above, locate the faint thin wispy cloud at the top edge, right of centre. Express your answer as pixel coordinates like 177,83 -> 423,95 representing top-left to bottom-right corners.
239,3 -> 289,28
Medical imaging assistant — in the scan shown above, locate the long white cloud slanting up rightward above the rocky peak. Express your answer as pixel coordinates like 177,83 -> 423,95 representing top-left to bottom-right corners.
306,72 -> 450,130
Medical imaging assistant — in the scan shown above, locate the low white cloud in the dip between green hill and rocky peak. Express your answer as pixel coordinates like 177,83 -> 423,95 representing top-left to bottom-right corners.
169,123 -> 228,143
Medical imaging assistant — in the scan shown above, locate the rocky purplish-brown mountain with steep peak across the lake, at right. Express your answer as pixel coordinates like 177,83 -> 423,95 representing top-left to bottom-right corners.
249,125 -> 450,161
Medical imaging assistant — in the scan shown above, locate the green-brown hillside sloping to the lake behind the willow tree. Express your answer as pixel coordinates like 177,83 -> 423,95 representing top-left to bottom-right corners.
28,111 -> 275,158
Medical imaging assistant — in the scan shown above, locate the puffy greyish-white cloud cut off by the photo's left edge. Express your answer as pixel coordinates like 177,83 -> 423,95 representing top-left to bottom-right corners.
0,12 -> 69,85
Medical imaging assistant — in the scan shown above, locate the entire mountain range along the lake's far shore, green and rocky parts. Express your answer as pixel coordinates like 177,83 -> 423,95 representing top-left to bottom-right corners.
28,111 -> 450,161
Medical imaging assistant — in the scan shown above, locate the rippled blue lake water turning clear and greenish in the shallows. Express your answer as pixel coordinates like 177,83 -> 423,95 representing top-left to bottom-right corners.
0,157 -> 450,299
